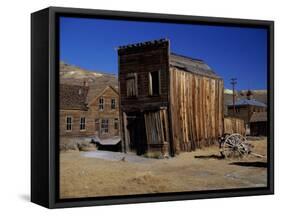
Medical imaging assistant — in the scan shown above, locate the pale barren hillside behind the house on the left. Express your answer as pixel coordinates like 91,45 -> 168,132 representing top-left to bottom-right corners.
60,61 -> 118,89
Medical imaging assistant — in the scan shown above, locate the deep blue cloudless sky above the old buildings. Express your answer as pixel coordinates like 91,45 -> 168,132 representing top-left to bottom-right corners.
60,17 -> 267,89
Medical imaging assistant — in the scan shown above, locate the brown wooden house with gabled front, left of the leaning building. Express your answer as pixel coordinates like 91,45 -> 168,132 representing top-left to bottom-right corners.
60,84 -> 120,138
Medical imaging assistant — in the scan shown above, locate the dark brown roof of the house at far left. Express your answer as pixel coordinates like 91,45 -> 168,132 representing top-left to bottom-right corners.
60,84 -> 89,110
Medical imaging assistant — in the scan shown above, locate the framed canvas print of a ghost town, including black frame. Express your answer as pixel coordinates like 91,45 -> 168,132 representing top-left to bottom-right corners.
31,7 -> 274,208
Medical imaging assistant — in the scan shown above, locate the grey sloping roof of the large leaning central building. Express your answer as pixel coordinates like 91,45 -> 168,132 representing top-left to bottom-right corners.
170,53 -> 220,78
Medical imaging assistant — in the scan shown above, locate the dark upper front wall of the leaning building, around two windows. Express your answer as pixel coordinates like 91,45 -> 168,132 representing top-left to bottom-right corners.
118,45 -> 169,112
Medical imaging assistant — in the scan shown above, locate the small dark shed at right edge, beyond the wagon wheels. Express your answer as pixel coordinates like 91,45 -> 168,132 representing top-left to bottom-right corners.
250,112 -> 267,136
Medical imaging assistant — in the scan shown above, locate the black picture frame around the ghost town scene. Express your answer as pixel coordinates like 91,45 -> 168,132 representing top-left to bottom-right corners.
31,7 -> 274,208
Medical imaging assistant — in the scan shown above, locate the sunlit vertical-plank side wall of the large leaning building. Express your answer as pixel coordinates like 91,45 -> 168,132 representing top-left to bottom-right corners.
170,68 -> 224,153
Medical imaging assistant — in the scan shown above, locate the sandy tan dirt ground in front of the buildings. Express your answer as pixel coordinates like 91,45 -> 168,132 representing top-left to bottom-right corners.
60,138 -> 267,198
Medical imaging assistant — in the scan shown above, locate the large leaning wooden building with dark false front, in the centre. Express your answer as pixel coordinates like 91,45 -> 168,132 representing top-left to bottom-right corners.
118,39 -> 223,156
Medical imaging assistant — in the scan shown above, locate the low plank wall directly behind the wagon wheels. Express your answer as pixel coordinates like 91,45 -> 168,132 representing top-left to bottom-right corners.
224,117 -> 246,135
